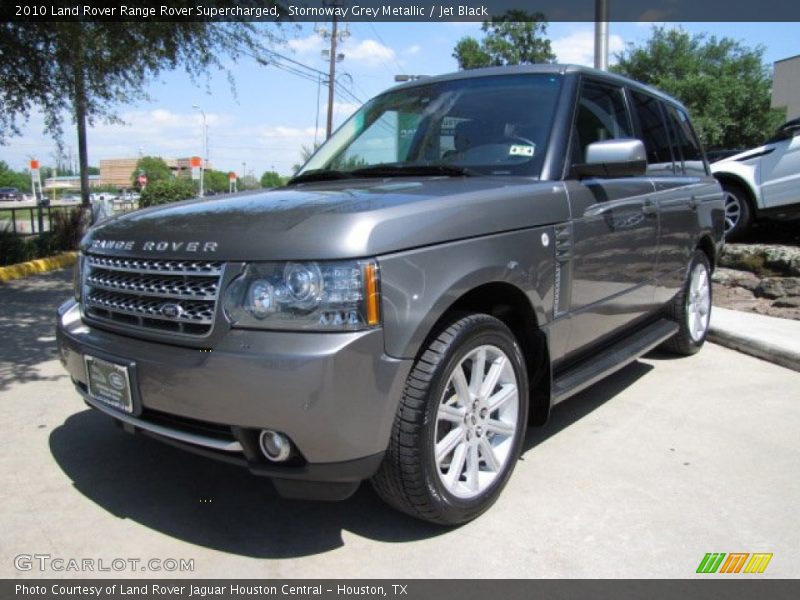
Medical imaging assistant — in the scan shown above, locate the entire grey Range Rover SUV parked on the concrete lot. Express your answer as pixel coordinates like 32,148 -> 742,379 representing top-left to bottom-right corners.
57,65 -> 725,524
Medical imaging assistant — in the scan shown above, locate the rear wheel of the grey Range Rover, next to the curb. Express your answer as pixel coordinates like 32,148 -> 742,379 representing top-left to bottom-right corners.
664,250 -> 712,356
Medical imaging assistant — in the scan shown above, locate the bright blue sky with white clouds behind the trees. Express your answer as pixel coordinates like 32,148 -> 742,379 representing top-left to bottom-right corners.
0,22 -> 800,177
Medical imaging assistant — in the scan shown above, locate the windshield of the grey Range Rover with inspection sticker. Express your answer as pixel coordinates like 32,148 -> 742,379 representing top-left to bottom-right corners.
298,74 -> 562,177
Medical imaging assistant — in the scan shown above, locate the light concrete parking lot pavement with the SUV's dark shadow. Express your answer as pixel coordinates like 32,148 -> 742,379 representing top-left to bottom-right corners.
0,271 -> 800,578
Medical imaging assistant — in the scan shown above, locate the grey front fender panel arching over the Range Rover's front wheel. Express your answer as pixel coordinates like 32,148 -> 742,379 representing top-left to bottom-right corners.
379,226 -> 555,358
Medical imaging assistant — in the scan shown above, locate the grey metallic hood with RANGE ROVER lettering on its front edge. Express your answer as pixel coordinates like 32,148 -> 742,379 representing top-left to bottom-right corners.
81,177 -> 569,261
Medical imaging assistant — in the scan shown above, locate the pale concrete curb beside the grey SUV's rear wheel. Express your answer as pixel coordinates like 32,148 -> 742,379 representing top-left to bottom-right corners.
708,306 -> 800,371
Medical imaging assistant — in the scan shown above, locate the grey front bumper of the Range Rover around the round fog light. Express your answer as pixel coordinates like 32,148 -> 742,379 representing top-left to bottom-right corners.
57,300 -> 411,497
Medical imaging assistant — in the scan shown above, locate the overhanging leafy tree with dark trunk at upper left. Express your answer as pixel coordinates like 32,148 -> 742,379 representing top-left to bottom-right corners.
0,13 -> 278,204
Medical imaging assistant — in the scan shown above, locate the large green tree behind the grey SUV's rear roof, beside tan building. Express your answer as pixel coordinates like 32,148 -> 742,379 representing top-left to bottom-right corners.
612,27 -> 784,148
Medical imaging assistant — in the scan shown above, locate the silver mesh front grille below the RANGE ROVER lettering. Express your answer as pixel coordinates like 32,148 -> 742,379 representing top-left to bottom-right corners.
83,255 -> 224,336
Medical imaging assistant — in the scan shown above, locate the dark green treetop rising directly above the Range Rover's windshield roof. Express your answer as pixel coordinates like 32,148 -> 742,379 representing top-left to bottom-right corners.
453,10 -> 556,69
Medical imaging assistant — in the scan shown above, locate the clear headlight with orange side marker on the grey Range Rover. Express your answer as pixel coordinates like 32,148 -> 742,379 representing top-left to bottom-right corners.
223,261 -> 380,331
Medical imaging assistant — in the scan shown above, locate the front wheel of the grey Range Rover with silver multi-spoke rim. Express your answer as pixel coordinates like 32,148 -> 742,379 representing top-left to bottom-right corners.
372,314 -> 528,525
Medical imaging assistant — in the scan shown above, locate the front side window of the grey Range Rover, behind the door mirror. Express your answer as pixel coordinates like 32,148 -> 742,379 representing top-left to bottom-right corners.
572,81 -> 631,163
